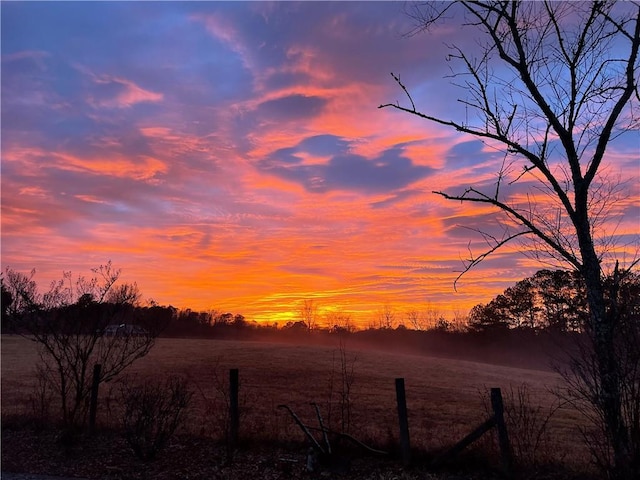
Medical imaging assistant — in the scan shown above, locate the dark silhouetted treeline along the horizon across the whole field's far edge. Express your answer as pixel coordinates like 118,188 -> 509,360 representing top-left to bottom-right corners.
2,264 -> 640,338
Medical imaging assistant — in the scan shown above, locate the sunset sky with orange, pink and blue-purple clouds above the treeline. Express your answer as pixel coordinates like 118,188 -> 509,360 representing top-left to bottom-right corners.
0,2 -> 640,325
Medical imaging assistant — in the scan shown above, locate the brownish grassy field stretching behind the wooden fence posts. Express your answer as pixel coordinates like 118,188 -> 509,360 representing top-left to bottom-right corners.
2,335 -> 585,463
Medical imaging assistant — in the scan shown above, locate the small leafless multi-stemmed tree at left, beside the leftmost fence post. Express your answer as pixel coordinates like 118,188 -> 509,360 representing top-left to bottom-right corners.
6,262 -> 160,427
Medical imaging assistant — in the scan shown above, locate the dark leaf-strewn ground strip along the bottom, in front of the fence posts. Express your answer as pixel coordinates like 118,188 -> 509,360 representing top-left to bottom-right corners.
2,426 -> 499,480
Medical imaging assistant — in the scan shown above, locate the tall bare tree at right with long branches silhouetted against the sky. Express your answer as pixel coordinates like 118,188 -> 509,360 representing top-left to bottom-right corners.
380,1 -> 640,478
